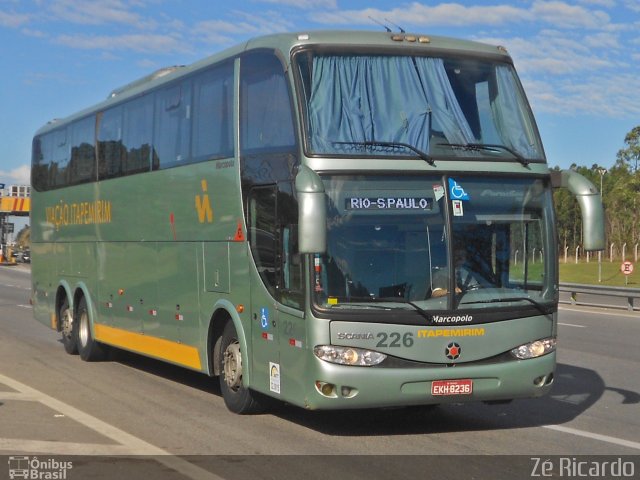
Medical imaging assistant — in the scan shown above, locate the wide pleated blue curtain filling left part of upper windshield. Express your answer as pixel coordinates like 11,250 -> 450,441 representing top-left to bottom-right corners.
309,56 -> 431,153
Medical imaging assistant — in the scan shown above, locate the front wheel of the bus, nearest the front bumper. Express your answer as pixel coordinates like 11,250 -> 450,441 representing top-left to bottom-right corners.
219,320 -> 263,415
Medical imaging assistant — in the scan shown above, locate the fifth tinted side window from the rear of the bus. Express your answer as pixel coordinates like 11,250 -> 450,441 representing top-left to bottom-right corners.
122,95 -> 153,175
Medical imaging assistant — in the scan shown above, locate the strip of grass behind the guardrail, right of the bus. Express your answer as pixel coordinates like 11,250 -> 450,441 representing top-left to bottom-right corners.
560,258 -> 640,288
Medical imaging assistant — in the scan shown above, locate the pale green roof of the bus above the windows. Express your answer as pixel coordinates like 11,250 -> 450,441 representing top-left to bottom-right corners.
36,30 -> 511,135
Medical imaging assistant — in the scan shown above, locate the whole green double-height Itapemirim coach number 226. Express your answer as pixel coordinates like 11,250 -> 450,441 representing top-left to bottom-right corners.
31,31 -> 604,413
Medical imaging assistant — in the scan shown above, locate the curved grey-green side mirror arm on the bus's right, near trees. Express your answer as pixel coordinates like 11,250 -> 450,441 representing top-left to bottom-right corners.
551,170 -> 605,251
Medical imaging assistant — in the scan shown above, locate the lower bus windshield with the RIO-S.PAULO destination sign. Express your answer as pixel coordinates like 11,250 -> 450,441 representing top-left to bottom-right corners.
313,176 -> 555,311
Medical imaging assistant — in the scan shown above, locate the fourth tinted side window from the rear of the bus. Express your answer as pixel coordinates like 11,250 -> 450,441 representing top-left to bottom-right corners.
98,107 -> 124,180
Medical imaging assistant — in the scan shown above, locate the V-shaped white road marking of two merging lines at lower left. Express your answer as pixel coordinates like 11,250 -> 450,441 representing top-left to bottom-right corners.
0,374 -> 222,480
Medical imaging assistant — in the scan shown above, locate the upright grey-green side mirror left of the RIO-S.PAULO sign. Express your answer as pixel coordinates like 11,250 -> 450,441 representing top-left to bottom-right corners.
296,165 -> 327,253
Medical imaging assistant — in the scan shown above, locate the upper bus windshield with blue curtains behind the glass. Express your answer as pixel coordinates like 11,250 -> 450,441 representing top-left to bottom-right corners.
296,52 -> 544,163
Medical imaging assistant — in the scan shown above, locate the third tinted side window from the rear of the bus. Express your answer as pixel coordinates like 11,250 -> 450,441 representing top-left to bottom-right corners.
69,116 -> 96,185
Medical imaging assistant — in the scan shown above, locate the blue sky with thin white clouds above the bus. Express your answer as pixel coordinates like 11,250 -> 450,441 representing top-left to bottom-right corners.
0,0 -> 640,190
